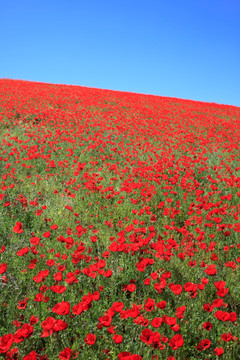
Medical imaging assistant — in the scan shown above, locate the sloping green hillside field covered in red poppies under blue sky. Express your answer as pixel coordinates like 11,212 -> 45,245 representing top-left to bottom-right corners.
0,79 -> 240,360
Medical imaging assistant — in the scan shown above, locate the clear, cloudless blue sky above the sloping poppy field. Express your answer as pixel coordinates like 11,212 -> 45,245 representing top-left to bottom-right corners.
0,0 -> 240,106
